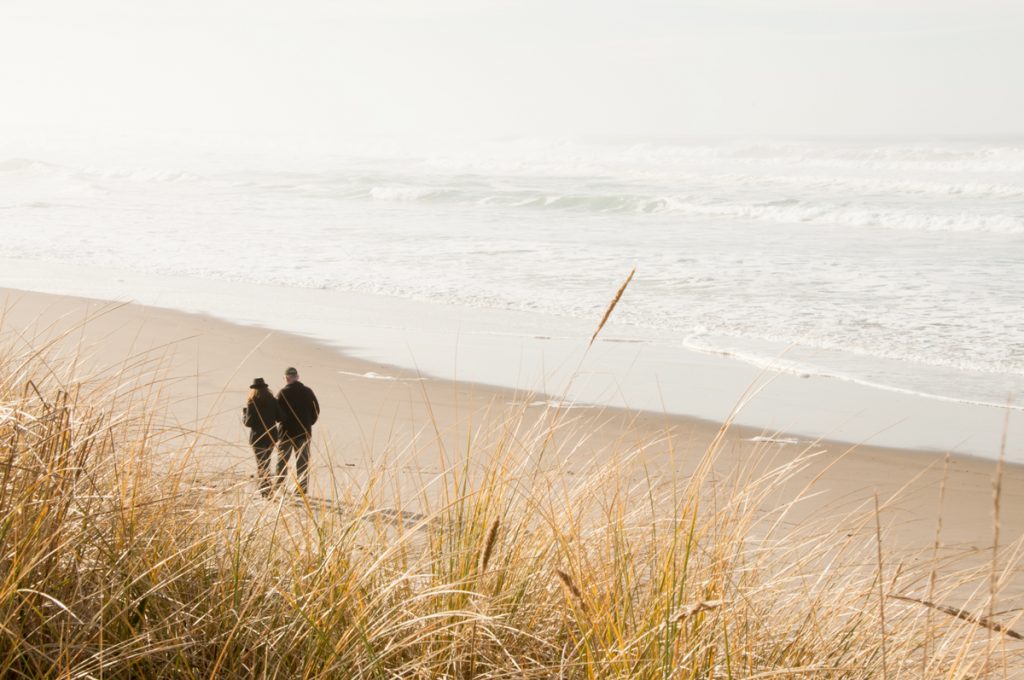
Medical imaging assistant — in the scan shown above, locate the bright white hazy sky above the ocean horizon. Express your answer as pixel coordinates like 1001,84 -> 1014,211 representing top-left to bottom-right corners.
0,0 -> 1024,144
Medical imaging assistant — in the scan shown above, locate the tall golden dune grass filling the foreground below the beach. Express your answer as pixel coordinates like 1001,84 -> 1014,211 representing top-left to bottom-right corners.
0,321 -> 1024,679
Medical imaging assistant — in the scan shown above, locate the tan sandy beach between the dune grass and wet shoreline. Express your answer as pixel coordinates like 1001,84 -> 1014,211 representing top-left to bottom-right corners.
6,289 -> 1024,608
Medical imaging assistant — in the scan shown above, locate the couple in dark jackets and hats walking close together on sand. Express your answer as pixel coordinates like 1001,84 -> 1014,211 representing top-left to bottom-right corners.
242,368 -> 319,498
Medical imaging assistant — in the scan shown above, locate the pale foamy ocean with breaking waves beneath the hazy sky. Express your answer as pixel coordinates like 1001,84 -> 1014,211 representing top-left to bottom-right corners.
0,139 -> 1024,406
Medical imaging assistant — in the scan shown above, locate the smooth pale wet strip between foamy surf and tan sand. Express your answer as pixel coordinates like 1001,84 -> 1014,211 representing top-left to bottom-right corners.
0,258 -> 1024,463
